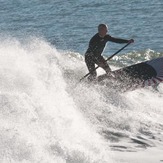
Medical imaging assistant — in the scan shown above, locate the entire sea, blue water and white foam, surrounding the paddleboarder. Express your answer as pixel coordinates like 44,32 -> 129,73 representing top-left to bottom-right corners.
0,0 -> 163,163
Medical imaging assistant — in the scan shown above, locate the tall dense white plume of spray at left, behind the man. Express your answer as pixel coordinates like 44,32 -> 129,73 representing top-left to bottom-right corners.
0,38 -> 111,163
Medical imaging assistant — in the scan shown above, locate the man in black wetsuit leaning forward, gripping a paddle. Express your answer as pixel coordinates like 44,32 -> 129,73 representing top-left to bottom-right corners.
85,24 -> 134,80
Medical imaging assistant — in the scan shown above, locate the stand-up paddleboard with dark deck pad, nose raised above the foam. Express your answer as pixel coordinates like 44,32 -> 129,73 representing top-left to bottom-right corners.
97,58 -> 163,91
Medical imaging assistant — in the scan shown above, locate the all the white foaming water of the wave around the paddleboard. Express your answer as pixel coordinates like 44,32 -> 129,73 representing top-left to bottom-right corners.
0,37 -> 163,163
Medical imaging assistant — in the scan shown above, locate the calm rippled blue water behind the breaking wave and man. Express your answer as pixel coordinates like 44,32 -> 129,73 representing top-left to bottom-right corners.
0,0 -> 163,55
